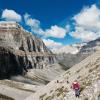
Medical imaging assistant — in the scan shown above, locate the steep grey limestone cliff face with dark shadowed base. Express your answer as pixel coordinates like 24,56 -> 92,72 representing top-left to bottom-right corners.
0,22 -> 55,78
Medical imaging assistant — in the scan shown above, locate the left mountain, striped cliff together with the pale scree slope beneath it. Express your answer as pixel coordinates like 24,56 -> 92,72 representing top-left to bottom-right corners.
0,21 -> 64,84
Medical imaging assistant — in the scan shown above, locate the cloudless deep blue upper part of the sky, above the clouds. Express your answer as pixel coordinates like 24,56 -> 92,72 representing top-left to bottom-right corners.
0,0 -> 96,27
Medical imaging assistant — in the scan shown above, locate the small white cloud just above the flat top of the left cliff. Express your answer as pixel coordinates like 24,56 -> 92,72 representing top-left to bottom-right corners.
1,9 -> 22,22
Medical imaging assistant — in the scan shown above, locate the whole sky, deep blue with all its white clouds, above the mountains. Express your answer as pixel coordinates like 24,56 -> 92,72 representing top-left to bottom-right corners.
0,0 -> 100,52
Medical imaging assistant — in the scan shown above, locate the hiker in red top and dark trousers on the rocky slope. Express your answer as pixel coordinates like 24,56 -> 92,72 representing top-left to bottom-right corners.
71,80 -> 80,97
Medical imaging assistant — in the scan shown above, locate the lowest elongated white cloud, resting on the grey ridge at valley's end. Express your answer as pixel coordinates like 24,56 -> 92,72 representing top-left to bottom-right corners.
43,39 -> 79,54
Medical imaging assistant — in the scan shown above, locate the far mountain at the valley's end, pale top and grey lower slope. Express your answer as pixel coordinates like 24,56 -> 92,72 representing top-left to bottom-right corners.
56,43 -> 88,70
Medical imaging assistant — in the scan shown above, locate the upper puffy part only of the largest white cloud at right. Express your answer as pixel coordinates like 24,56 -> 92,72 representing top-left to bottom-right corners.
74,5 -> 100,28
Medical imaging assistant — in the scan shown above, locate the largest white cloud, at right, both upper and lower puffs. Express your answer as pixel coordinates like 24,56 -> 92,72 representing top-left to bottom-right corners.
70,5 -> 100,41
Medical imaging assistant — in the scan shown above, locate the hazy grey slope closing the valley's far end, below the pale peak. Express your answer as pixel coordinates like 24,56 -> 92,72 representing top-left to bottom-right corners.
56,53 -> 88,70
